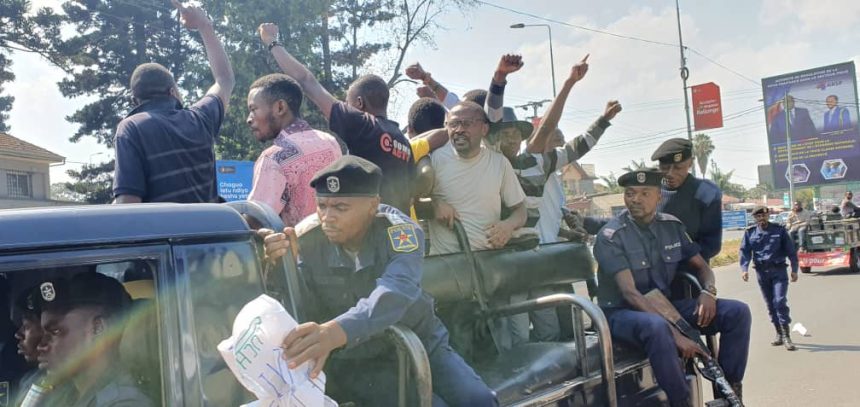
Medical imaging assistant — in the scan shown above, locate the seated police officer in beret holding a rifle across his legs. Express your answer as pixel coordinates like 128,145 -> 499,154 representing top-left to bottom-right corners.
594,169 -> 751,406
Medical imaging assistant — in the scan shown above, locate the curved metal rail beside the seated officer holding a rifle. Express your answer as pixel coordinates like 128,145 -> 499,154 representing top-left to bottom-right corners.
490,294 -> 618,407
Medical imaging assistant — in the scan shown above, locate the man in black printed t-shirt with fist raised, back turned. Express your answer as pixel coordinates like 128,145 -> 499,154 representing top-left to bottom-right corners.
259,23 -> 415,213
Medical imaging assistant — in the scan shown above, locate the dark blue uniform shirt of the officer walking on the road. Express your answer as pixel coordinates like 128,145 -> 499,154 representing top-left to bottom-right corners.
740,222 -> 798,273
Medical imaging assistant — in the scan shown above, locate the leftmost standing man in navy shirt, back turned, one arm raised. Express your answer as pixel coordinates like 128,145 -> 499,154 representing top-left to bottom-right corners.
113,1 -> 235,203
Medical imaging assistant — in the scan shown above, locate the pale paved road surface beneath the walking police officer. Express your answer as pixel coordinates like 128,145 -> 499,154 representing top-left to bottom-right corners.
705,265 -> 860,407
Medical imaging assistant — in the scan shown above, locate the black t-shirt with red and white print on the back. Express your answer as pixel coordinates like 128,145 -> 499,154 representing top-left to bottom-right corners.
329,102 -> 415,213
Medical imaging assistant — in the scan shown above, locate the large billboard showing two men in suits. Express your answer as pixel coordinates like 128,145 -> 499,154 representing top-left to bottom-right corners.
761,62 -> 860,189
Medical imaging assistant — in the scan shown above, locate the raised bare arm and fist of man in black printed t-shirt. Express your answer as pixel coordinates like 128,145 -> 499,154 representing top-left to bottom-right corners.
257,23 -> 338,120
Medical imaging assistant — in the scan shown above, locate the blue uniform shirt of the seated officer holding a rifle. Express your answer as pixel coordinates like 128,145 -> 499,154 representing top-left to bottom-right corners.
594,209 -> 699,308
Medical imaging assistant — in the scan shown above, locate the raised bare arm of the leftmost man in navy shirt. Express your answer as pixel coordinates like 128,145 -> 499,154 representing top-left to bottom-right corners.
172,0 -> 236,111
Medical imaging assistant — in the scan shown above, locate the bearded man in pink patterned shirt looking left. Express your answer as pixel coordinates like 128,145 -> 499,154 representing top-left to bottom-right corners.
247,74 -> 341,226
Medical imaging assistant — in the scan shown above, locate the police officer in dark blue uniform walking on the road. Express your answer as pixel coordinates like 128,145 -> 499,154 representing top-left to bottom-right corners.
740,205 -> 798,350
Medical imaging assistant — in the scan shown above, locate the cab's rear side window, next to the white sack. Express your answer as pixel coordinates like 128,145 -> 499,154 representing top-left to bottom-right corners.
174,240 -> 264,406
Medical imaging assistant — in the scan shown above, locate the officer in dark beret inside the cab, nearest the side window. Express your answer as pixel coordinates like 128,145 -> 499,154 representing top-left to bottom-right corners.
30,271 -> 152,407
